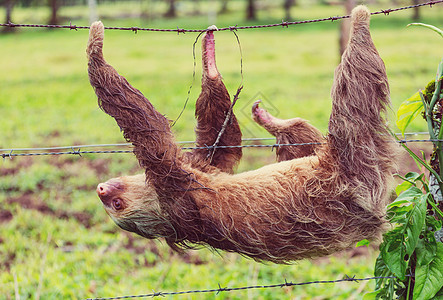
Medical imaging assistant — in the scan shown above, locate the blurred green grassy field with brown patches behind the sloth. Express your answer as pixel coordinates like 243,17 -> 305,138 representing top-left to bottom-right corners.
0,1 -> 443,299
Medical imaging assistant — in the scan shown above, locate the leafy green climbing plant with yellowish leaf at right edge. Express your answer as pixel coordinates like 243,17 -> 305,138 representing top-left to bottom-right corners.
374,23 -> 443,299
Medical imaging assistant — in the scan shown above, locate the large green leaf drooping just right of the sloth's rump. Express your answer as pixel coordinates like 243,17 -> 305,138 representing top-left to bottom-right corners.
380,190 -> 429,280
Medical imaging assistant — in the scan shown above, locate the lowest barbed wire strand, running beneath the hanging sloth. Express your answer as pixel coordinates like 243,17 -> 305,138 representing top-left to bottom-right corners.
87,275 -> 400,300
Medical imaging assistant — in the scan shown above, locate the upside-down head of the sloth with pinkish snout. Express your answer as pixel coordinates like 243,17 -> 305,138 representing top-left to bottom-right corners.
97,174 -> 172,239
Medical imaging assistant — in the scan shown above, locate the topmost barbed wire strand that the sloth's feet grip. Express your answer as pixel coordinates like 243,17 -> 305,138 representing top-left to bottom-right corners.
0,0 -> 443,34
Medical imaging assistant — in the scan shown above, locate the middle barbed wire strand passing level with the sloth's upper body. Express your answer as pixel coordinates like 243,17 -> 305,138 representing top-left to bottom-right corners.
0,132 -> 443,159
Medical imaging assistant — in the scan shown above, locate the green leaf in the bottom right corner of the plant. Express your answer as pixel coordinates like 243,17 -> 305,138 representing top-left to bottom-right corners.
414,243 -> 443,300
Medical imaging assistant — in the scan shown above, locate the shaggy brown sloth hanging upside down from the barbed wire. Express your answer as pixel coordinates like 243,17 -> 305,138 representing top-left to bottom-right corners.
87,6 -> 395,263
